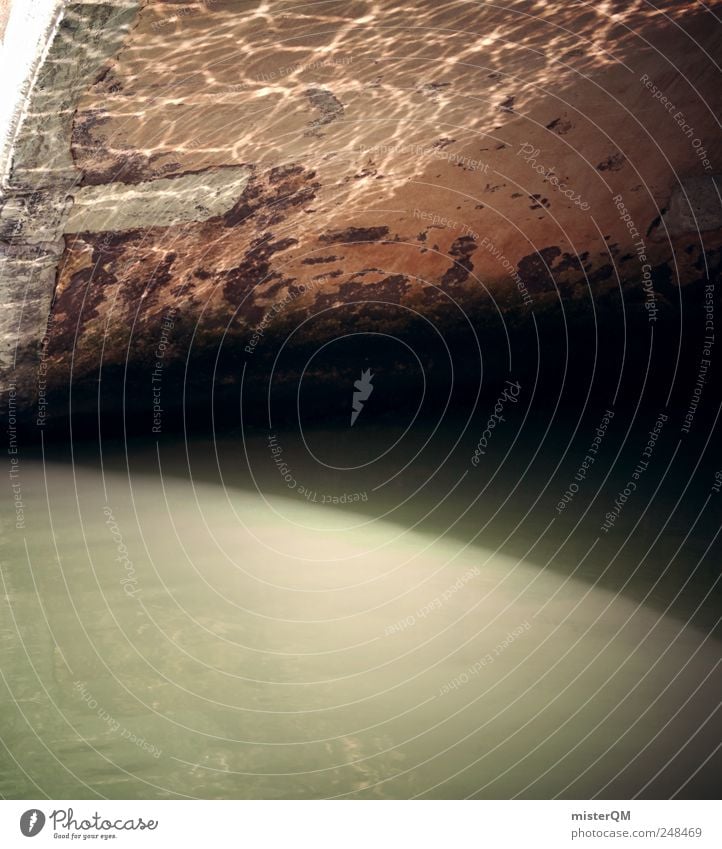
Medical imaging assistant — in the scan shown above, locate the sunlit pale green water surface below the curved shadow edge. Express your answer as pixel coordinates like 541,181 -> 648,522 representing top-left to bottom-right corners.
0,431 -> 720,798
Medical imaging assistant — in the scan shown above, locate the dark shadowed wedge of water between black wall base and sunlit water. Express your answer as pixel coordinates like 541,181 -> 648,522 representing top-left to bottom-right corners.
62,404 -> 722,631
